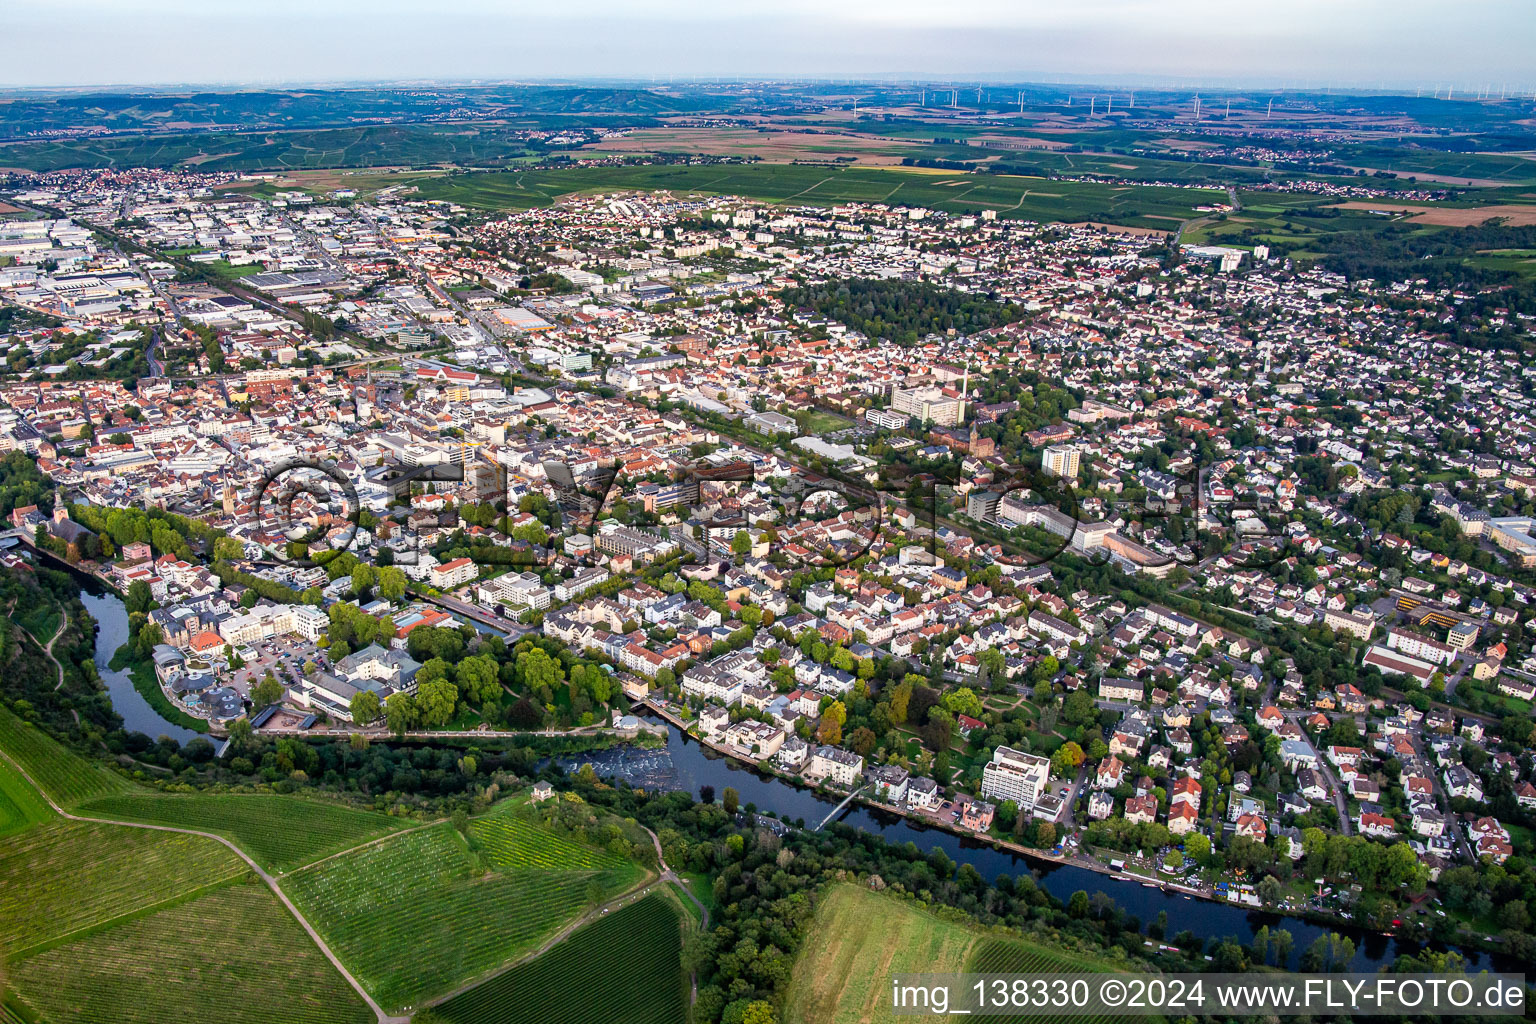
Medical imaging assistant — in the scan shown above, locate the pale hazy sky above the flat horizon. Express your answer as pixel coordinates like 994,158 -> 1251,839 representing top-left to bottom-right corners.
0,0 -> 1536,91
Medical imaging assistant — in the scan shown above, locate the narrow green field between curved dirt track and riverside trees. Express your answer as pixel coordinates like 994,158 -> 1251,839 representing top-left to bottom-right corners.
80,792 -> 402,872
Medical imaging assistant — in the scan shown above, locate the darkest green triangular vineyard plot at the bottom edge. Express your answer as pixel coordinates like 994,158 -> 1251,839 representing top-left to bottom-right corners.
436,895 -> 688,1024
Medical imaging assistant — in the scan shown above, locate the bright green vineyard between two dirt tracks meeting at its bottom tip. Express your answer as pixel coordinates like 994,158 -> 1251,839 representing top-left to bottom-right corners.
283,821 -> 642,1009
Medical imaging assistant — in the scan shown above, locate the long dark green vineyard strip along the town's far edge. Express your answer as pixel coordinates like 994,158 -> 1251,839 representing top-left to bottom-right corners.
416,164 -> 1226,230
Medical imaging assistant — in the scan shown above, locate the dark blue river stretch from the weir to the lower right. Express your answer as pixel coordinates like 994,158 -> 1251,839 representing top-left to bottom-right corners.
561,715 -> 1513,970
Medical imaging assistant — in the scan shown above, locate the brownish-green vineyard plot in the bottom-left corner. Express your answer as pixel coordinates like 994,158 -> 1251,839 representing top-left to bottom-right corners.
9,884 -> 375,1024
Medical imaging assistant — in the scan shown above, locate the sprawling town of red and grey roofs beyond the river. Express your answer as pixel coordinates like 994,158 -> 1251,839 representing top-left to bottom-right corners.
9,158 -> 1536,958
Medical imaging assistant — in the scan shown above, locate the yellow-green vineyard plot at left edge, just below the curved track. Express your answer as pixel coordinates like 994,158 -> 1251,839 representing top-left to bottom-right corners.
0,821 -> 249,956
